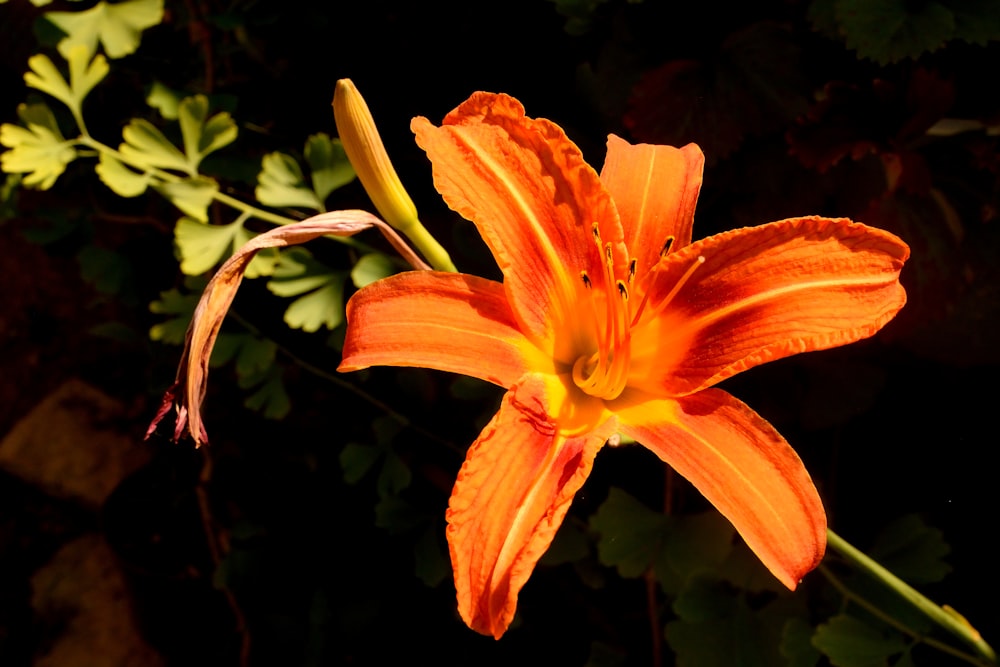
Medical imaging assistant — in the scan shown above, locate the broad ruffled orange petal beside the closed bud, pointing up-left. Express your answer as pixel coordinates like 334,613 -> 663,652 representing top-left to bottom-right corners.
411,93 -> 626,362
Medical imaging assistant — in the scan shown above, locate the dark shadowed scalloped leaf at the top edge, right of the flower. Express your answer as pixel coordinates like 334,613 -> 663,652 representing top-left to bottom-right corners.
835,0 -> 955,65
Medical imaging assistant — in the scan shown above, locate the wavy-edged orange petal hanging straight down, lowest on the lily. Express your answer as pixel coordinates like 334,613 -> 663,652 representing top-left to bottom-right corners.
447,375 -> 617,639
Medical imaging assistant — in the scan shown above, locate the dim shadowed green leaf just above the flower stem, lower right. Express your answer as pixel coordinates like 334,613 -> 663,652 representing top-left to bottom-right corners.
870,514 -> 951,584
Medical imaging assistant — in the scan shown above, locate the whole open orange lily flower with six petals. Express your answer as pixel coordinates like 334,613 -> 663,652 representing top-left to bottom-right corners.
339,93 -> 909,638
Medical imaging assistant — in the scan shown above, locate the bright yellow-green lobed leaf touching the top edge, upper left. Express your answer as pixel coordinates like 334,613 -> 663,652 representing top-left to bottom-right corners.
45,0 -> 163,58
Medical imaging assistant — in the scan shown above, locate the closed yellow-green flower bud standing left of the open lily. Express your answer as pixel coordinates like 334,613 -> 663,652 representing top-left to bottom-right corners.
333,79 -> 455,271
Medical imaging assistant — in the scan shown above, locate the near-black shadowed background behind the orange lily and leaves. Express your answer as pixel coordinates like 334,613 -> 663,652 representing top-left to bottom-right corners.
0,0 -> 1000,665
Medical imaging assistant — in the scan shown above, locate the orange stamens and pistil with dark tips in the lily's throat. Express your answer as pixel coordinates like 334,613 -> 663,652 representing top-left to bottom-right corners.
573,228 -> 705,400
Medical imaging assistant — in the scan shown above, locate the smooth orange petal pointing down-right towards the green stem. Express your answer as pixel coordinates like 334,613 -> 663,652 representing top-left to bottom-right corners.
612,389 -> 826,590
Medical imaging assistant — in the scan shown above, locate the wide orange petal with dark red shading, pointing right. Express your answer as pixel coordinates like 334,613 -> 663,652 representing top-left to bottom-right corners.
629,217 -> 909,396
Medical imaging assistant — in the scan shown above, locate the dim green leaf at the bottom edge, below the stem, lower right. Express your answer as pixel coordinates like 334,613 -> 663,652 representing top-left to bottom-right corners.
812,614 -> 906,667
